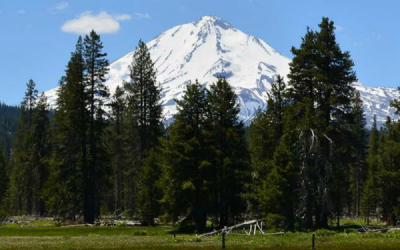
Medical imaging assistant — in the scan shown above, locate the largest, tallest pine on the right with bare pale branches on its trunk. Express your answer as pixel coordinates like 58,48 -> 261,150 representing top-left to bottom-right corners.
288,18 -> 356,227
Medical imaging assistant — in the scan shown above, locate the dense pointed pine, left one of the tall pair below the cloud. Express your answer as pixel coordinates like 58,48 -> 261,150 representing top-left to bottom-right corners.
46,37 -> 90,220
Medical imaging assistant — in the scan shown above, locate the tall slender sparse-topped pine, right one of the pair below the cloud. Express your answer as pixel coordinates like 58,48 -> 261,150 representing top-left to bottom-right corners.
83,30 -> 109,223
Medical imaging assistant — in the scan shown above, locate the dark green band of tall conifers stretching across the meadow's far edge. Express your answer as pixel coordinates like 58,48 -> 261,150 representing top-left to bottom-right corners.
0,18 -> 400,232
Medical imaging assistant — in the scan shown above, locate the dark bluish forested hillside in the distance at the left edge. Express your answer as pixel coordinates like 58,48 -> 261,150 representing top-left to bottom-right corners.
0,103 -> 21,159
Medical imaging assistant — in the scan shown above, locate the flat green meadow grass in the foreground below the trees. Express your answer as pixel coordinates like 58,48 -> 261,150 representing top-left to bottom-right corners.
0,224 -> 400,250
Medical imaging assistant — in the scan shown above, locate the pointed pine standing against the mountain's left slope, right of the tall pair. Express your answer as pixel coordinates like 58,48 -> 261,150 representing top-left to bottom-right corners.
124,40 -> 163,220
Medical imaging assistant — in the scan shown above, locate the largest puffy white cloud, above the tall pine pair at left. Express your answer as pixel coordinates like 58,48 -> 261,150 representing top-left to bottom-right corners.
61,11 -> 130,34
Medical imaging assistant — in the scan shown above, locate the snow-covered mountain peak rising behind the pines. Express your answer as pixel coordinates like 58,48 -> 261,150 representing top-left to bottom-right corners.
46,16 -> 398,127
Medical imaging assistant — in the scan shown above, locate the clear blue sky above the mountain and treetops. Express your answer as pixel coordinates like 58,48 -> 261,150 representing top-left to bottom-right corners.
0,0 -> 400,104
